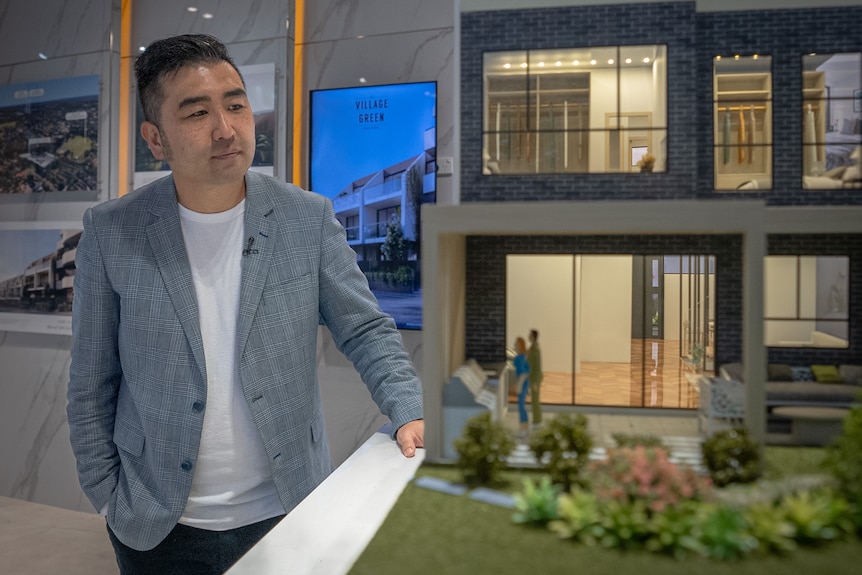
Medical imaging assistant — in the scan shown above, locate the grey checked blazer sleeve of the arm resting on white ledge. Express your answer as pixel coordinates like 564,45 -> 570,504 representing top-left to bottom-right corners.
320,200 -> 422,437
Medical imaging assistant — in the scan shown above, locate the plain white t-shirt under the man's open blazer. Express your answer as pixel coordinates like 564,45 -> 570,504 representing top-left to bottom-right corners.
179,200 -> 284,531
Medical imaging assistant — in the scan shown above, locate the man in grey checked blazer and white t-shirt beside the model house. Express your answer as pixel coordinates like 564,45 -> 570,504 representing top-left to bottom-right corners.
68,35 -> 424,574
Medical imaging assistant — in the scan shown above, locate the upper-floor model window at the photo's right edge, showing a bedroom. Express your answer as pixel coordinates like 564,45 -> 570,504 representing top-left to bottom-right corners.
802,52 -> 862,190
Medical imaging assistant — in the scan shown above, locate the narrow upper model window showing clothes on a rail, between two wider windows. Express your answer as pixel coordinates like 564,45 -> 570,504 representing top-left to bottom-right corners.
713,55 -> 772,190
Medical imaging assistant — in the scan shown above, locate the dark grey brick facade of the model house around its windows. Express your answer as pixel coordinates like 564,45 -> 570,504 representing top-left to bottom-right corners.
460,2 -> 862,374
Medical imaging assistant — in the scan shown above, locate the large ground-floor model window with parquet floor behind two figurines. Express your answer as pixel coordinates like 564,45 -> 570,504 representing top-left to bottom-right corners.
505,254 -> 716,408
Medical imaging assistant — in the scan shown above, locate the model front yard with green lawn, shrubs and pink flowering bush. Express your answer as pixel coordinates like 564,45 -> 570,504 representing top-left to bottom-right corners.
351,407 -> 862,575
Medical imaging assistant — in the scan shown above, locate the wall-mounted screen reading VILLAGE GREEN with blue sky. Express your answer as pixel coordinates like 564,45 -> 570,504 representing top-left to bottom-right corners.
309,82 -> 437,329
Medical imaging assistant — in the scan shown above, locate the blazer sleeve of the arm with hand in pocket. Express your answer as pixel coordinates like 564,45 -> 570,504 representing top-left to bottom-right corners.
67,208 -> 122,509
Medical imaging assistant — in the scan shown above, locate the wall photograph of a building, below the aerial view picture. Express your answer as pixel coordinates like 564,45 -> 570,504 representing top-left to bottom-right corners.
0,222 -> 81,335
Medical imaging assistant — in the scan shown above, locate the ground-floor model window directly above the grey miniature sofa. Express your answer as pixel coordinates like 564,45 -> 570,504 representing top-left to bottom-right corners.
763,256 -> 850,348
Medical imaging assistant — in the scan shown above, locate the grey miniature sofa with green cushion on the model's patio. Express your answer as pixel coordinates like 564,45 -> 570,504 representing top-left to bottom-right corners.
719,363 -> 862,410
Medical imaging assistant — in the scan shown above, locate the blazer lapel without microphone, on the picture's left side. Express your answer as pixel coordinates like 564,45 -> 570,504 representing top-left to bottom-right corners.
147,177 -> 206,380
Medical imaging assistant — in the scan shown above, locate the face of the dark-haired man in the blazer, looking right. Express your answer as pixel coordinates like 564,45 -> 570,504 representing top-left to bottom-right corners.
141,62 -> 255,188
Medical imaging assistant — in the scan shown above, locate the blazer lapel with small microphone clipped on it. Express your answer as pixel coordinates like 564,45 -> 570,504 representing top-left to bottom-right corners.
236,173 -> 278,357
